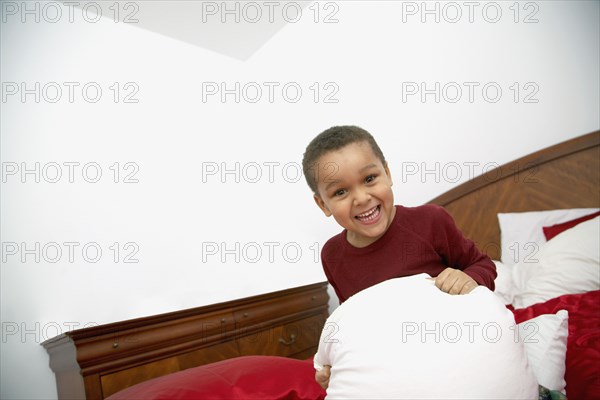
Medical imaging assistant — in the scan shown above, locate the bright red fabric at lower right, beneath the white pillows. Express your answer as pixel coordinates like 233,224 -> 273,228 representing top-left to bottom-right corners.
513,290 -> 600,400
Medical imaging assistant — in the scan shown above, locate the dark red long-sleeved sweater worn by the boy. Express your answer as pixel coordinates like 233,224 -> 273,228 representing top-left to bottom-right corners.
321,204 -> 496,303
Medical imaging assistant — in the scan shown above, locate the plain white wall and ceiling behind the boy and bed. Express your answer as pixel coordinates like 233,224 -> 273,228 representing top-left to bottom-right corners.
0,1 -> 600,399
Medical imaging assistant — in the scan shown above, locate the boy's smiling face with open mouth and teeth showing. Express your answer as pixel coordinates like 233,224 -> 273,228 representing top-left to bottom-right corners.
314,142 -> 396,247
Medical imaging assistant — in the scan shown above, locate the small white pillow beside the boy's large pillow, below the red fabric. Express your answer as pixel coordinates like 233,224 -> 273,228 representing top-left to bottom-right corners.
517,310 -> 569,393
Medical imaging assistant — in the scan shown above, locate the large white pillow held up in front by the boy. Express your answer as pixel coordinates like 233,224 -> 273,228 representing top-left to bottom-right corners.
314,274 -> 538,399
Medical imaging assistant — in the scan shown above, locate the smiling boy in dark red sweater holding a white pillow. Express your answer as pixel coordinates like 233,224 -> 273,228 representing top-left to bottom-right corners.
302,126 -> 496,389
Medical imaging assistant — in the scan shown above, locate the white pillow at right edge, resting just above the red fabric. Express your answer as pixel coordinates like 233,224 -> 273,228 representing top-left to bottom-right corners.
513,217 -> 600,308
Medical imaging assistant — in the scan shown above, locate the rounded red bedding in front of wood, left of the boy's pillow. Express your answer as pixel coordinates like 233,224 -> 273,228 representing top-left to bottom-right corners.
107,356 -> 325,400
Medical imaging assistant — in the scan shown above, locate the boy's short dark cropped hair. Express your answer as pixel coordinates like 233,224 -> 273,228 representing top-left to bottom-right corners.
302,125 -> 386,194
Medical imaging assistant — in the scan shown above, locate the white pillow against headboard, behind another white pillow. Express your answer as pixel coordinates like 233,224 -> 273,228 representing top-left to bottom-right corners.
498,208 -> 598,265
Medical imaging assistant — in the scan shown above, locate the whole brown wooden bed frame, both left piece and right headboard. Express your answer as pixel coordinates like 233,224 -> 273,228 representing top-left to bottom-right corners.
42,131 -> 600,400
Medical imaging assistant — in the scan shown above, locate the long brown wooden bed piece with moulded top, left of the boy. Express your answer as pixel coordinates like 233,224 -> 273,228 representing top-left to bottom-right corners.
42,282 -> 329,400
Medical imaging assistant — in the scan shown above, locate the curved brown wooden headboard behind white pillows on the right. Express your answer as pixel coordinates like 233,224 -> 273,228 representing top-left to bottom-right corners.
429,131 -> 600,260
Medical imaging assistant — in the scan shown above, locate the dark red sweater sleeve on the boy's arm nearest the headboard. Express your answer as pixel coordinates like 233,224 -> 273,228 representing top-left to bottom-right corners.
433,206 -> 497,291
